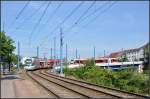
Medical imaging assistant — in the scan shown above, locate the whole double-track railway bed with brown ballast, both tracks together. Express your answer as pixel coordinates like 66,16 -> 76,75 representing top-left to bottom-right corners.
27,70 -> 148,98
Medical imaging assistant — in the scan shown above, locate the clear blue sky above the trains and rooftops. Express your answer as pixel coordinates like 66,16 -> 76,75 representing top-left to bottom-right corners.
1,1 -> 149,59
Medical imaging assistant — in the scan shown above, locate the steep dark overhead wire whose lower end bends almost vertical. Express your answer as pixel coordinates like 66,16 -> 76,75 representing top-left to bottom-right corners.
29,1 -> 51,44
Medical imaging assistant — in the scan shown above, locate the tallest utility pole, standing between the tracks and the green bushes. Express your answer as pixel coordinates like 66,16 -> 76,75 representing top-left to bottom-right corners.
60,28 -> 63,76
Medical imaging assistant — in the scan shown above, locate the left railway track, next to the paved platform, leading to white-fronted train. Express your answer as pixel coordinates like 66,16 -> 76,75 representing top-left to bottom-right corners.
27,71 -> 89,98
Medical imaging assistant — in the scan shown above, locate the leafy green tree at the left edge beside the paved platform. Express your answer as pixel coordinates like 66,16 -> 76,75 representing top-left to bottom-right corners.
0,31 -> 16,71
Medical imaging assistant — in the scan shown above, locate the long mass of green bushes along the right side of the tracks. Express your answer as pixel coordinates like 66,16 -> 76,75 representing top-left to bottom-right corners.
64,60 -> 148,94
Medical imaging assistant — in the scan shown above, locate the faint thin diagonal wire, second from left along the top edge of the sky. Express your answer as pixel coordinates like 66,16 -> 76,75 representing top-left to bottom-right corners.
16,3 -> 45,29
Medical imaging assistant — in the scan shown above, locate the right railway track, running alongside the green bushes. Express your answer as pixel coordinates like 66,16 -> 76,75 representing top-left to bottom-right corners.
40,70 -> 149,98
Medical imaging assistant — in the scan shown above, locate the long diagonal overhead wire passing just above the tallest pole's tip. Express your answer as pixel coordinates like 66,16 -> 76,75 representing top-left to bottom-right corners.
40,1 -> 84,46
